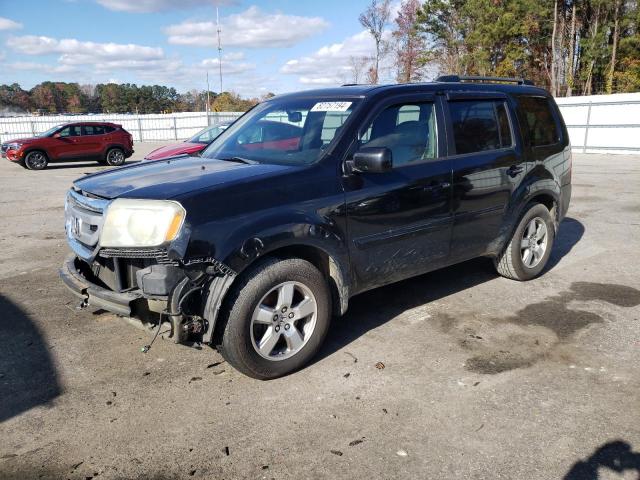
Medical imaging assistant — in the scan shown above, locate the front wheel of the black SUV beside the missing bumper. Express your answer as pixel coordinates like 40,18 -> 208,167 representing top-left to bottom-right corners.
216,258 -> 331,380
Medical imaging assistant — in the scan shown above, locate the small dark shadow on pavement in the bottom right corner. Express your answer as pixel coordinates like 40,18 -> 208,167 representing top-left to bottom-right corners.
564,440 -> 640,480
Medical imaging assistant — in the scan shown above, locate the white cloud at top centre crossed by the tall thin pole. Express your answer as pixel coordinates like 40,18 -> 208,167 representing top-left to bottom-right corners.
165,6 -> 329,48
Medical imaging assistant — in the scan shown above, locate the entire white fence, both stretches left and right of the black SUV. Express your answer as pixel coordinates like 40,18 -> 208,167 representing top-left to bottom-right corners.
0,93 -> 640,154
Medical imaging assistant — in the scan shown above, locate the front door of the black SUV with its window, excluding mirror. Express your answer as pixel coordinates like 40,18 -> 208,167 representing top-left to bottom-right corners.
344,95 -> 451,291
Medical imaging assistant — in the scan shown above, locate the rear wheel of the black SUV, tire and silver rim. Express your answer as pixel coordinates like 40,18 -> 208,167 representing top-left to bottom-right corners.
494,203 -> 556,281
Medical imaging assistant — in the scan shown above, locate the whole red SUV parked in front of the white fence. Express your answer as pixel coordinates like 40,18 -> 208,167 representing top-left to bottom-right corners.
2,122 -> 133,170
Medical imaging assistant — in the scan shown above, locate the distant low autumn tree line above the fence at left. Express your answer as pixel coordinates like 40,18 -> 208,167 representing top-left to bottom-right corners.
0,82 -> 264,114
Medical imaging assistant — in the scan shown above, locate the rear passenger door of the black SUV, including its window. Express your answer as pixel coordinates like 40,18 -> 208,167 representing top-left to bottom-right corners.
447,92 -> 526,261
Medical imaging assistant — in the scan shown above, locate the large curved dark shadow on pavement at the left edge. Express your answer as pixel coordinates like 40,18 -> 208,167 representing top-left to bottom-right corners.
0,295 -> 61,422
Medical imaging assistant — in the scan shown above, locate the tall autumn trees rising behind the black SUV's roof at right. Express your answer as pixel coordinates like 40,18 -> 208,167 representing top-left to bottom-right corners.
350,0 -> 640,96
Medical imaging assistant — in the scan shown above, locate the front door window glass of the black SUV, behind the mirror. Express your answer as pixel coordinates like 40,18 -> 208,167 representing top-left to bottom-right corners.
359,102 -> 438,167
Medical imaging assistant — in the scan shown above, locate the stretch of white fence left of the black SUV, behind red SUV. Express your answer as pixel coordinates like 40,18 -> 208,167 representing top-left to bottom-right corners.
0,112 -> 242,142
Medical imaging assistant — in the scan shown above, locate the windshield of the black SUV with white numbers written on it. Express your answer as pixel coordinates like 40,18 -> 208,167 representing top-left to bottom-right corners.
202,98 -> 360,165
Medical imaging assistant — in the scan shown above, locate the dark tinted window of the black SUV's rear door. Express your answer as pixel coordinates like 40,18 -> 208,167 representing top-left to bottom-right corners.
449,100 -> 513,155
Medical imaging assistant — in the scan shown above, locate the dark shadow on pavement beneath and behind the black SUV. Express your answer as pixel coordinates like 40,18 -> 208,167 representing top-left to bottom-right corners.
315,218 -> 585,361
